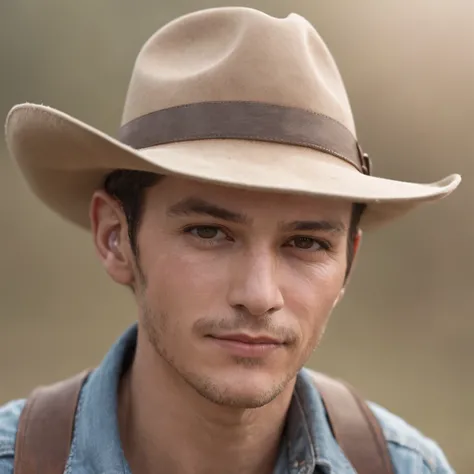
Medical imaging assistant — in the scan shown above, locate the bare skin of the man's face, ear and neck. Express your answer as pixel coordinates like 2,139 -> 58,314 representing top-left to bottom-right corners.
90,177 -> 360,474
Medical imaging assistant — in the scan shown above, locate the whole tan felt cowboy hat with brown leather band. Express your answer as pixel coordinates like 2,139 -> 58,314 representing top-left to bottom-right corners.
2,7 -> 461,228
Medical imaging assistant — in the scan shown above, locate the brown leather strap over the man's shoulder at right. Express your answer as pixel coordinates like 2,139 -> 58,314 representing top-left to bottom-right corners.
312,372 -> 394,474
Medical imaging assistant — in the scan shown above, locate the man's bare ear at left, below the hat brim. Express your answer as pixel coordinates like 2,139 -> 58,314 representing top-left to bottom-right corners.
89,190 -> 134,286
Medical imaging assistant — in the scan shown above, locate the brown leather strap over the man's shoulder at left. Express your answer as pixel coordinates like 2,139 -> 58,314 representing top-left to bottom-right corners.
14,371 -> 90,474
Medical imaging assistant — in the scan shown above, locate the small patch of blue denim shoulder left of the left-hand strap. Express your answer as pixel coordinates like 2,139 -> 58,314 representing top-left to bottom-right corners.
0,400 -> 25,474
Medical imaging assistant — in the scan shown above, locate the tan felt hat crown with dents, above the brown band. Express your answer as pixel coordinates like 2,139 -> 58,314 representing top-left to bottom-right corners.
122,7 -> 355,135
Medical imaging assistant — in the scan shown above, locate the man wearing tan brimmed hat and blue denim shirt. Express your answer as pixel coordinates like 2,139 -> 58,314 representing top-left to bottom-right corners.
0,8 -> 460,474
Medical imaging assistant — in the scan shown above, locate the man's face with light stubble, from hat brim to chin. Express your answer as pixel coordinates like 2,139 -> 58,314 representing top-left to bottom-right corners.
116,177 -> 351,407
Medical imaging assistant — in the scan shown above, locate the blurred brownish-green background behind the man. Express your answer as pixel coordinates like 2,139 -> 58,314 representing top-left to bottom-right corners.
0,0 -> 474,474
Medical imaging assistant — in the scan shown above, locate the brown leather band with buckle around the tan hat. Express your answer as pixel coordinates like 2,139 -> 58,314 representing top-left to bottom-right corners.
118,101 -> 370,174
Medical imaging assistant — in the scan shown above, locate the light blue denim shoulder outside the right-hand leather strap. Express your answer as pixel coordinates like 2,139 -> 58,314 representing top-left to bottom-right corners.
369,402 -> 454,474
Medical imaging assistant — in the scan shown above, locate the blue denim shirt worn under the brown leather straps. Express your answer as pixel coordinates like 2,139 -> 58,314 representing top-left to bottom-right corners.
0,326 -> 454,474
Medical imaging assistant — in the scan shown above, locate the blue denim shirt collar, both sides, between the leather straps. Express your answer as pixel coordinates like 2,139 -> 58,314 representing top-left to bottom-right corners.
67,325 -> 355,474
